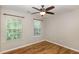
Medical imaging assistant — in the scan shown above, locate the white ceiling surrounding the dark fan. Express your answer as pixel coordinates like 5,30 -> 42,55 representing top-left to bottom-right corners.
3,5 -> 79,17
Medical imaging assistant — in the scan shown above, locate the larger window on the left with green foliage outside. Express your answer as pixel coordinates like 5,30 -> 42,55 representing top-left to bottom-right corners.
6,16 -> 22,40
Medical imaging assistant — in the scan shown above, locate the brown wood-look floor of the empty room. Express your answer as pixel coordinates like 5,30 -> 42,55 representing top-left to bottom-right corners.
4,41 -> 79,54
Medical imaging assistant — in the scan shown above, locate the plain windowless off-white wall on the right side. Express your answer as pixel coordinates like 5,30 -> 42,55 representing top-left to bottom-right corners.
45,10 -> 79,50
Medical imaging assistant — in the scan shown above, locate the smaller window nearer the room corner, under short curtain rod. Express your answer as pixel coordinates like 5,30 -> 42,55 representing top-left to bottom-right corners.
34,20 -> 41,36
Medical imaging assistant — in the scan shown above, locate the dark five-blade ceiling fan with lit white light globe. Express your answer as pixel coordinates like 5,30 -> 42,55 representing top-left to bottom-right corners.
32,5 -> 55,16
